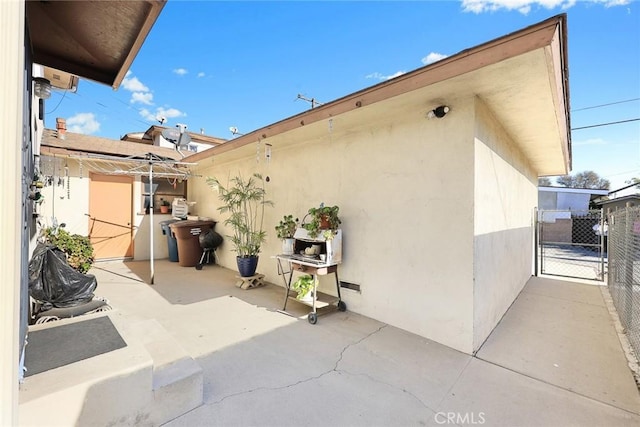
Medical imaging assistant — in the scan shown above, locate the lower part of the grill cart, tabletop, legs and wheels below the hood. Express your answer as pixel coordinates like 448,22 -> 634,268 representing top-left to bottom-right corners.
276,255 -> 347,325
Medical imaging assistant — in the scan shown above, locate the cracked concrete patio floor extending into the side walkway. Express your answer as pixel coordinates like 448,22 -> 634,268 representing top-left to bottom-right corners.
21,261 -> 640,427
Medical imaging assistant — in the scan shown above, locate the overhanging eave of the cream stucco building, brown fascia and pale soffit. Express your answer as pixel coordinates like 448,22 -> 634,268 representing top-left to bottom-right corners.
185,14 -> 571,176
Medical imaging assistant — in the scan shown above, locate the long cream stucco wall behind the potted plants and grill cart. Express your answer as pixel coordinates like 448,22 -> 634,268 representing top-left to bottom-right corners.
189,99 -> 473,352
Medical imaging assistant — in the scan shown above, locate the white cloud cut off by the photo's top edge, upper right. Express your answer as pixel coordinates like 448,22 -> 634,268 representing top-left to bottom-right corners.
462,0 -> 630,15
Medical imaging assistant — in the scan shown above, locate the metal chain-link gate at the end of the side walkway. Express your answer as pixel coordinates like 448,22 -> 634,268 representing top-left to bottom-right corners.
536,210 -> 608,281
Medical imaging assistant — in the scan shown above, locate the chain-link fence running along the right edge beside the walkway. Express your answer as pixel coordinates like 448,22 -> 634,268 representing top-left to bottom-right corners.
608,206 -> 640,355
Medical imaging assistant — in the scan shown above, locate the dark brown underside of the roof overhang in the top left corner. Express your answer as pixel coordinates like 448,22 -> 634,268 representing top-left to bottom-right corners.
26,0 -> 166,89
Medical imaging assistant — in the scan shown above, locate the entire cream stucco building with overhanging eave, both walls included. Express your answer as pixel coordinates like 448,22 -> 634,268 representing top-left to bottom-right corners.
186,15 -> 571,353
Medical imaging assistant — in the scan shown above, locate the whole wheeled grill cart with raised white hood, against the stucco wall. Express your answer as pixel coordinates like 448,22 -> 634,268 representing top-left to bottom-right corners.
275,228 -> 347,325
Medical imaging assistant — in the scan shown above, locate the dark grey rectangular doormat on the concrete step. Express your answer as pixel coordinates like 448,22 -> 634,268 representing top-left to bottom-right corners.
24,316 -> 127,377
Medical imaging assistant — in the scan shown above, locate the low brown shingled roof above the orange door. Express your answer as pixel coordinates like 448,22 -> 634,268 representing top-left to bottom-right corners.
40,129 -> 182,160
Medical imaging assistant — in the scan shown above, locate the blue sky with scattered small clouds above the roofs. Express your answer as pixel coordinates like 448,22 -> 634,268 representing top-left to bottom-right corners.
45,0 -> 640,189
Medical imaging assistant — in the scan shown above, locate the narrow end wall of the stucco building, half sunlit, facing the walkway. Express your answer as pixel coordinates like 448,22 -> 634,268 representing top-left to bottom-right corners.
473,99 -> 538,351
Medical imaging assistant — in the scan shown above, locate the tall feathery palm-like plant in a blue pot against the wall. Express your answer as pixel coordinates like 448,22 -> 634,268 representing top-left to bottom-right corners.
207,173 -> 273,277
